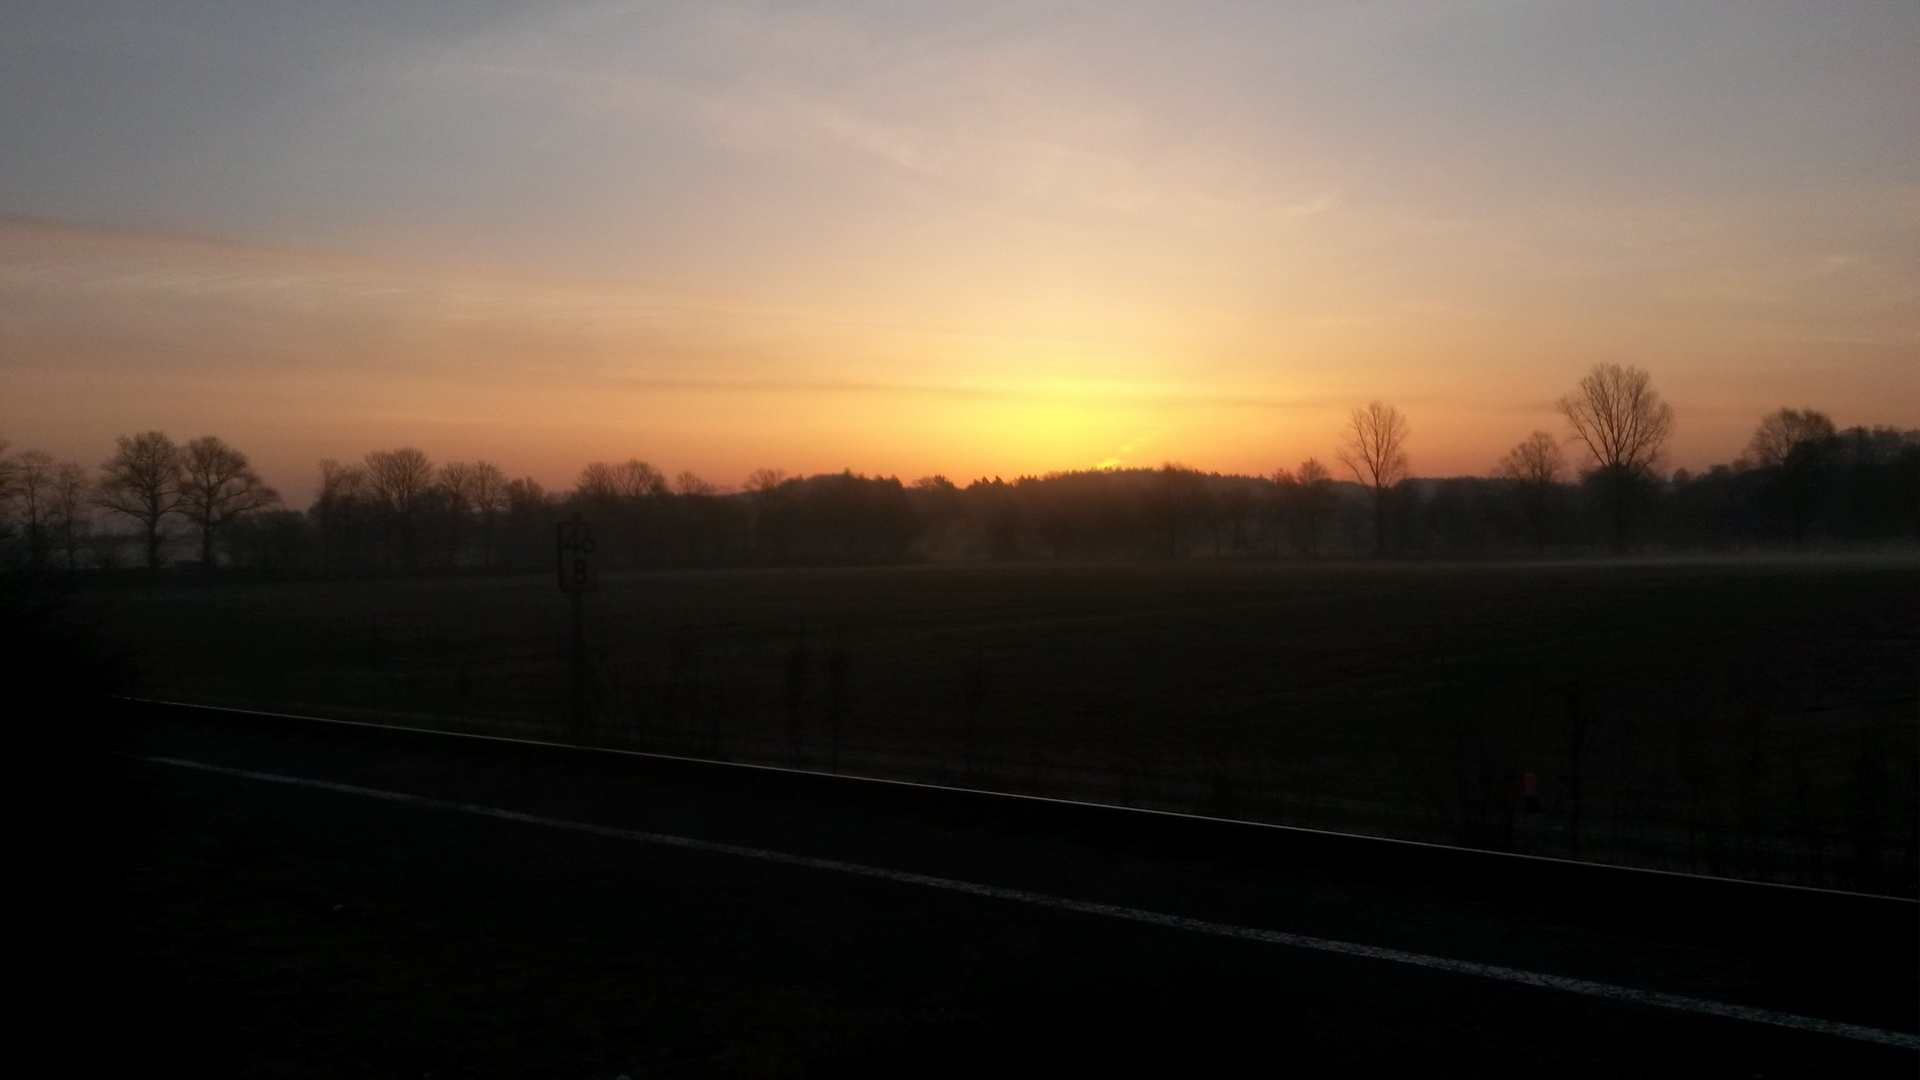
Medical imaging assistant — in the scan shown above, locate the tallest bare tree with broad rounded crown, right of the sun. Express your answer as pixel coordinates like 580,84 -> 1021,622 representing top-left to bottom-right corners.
1559,363 -> 1674,552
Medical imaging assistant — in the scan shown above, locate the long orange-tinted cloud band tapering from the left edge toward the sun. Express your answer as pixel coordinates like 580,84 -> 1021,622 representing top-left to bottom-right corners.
0,217 -> 1321,409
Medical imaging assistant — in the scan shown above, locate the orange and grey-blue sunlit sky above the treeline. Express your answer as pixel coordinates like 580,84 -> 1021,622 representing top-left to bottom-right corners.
0,0 -> 1920,503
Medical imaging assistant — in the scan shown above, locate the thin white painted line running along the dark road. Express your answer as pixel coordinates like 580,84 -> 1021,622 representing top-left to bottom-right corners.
146,757 -> 1920,1049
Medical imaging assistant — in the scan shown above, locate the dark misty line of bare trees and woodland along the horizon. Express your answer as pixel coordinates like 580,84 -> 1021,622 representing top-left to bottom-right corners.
0,365 -> 1920,575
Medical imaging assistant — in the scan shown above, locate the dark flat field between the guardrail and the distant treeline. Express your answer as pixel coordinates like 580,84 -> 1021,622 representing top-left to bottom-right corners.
81,557 -> 1920,896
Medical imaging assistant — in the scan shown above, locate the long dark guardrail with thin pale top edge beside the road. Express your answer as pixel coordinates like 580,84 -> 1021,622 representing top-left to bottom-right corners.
117,698 -> 1920,957
